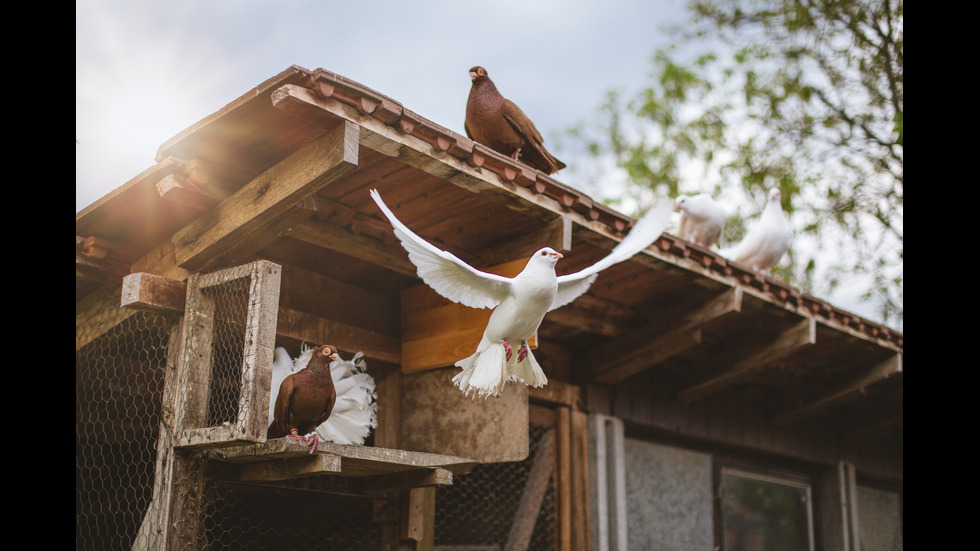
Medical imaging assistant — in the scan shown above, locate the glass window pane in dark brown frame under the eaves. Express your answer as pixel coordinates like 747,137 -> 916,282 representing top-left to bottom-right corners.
722,469 -> 813,551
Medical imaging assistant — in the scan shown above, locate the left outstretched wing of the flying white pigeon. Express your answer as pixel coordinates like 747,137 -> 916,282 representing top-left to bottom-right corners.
371,189 -> 511,308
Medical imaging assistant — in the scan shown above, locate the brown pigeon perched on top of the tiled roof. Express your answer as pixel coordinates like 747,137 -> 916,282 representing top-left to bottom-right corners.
463,67 -> 565,174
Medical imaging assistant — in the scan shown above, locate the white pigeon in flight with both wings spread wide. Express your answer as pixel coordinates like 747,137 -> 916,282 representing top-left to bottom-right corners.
371,189 -> 671,398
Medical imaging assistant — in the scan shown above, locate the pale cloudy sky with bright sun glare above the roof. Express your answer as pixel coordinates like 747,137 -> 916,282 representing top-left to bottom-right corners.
75,0 -> 896,328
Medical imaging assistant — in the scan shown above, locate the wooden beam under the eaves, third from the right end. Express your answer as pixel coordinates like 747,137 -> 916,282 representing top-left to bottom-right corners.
589,287 -> 742,384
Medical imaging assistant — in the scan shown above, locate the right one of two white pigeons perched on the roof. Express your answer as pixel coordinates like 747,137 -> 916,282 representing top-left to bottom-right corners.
719,188 -> 793,274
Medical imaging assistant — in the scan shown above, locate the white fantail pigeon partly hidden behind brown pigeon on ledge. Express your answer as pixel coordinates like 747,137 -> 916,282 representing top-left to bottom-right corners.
269,346 -> 378,445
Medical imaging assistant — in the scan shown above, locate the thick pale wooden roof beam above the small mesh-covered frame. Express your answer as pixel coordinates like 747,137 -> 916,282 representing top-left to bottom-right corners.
172,122 -> 359,271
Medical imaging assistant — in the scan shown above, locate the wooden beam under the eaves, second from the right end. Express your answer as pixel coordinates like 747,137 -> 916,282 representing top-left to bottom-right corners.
677,317 -> 817,403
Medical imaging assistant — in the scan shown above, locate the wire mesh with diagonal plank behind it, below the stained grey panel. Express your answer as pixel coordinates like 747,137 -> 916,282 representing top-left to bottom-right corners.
435,423 -> 557,551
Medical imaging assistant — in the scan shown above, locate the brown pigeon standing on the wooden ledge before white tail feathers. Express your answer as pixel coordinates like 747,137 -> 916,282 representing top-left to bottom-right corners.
267,344 -> 340,453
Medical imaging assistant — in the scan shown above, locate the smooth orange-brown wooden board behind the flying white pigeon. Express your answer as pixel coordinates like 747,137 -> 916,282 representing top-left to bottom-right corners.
401,258 -> 537,373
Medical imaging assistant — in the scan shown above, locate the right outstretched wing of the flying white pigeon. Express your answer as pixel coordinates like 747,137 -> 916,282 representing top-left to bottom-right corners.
551,201 -> 673,310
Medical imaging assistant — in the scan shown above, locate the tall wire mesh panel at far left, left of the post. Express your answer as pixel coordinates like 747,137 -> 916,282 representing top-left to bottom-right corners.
75,313 -> 179,551
